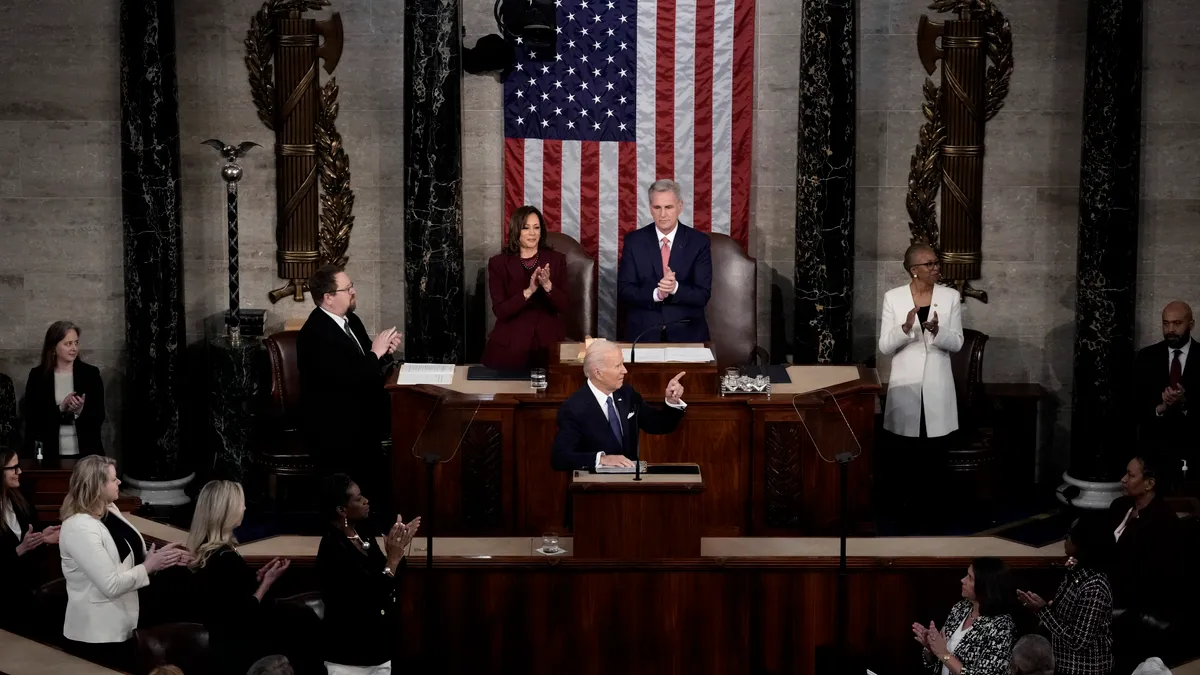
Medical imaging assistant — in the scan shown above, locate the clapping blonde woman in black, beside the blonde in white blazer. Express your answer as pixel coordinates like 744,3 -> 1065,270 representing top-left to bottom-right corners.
187,480 -> 290,673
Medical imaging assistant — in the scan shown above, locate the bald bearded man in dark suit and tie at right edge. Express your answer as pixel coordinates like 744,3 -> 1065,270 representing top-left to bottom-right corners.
1134,300 -> 1200,468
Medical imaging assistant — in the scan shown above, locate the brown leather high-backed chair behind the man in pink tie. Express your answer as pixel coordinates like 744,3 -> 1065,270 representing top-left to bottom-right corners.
704,233 -> 769,368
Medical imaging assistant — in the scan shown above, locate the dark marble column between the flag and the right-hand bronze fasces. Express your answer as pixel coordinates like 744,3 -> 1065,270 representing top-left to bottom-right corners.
792,0 -> 857,363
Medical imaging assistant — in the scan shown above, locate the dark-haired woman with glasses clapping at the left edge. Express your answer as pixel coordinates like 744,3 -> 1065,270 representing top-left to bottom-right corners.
0,448 -> 59,631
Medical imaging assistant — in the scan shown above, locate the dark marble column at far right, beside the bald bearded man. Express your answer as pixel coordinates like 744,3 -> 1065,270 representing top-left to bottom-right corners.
1066,0 -> 1142,508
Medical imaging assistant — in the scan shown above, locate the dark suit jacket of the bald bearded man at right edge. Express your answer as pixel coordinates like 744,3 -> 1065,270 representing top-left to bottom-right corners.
1134,340 -> 1200,456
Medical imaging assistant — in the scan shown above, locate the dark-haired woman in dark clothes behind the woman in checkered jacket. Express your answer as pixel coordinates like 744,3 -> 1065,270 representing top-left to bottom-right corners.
1109,453 -> 1182,673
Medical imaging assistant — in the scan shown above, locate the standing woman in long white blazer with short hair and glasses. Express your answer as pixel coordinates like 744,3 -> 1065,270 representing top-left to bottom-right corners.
880,244 -> 962,438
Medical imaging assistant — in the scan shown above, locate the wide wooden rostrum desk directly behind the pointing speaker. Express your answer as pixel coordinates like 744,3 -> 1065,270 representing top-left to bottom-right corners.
388,364 -> 880,537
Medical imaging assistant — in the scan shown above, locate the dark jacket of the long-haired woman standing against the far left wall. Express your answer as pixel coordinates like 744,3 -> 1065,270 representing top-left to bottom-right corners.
23,359 -> 104,459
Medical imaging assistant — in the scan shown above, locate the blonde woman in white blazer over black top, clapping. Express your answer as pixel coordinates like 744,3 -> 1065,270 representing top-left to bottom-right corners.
59,455 -> 188,670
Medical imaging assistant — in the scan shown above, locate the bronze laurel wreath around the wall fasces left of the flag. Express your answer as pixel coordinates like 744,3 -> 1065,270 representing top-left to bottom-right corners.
244,0 -> 354,265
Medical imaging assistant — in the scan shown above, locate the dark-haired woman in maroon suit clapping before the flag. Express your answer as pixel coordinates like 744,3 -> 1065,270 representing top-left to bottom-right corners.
482,207 -> 570,370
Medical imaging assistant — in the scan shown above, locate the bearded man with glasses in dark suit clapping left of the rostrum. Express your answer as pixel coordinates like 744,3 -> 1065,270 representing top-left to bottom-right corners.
296,265 -> 401,478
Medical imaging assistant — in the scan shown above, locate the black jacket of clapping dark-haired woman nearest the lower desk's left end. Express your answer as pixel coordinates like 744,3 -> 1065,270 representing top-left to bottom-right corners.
317,521 -> 400,665
